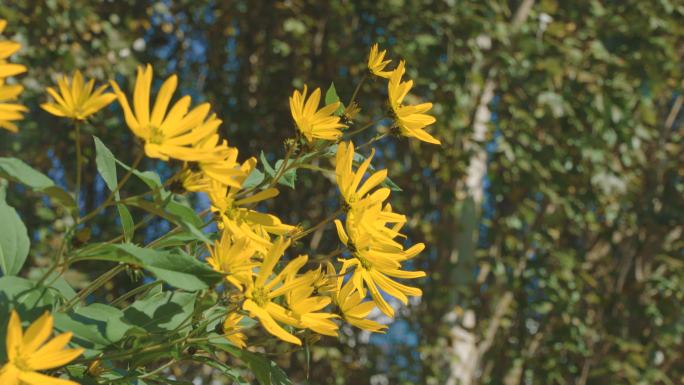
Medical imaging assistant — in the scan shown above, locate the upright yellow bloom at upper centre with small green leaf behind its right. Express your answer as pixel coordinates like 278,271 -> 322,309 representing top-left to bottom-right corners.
290,84 -> 347,142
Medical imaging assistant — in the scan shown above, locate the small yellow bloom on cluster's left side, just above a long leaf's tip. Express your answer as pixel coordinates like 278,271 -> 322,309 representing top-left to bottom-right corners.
207,231 -> 257,289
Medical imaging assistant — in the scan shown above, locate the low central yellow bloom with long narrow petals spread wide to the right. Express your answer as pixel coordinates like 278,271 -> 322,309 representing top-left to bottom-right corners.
242,237 -> 307,345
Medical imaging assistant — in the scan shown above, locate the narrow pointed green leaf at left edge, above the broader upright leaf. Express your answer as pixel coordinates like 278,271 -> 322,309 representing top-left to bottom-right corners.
0,158 -> 76,210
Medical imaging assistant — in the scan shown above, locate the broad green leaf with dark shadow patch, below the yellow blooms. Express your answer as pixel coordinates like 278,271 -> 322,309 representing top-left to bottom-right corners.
124,291 -> 196,332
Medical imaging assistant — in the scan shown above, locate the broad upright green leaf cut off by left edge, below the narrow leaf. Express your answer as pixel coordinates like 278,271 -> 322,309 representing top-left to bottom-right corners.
0,196 -> 31,275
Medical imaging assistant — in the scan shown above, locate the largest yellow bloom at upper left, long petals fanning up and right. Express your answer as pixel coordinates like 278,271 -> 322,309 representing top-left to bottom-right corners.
110,64 -> 225,162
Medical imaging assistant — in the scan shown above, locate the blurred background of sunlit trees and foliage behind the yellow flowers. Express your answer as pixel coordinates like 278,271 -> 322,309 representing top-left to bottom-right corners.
0,0 -> 684,385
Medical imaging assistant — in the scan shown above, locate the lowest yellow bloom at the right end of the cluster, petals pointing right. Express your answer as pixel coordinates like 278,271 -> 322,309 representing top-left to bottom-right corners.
333,264 -> 387,333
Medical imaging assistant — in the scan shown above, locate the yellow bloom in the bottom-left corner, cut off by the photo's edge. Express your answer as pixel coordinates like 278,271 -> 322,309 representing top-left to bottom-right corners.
0,311 -> 83,385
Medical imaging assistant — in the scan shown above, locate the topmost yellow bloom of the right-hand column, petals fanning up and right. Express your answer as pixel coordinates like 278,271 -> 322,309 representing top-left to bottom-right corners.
335,142 -> 390,209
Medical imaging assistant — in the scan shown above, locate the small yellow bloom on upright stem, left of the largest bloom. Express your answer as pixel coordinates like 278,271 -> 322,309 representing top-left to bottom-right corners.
40,70 -> 116,120
